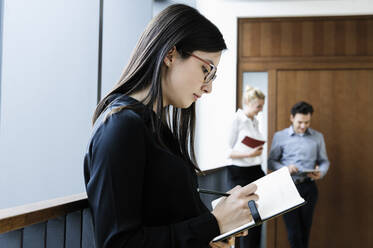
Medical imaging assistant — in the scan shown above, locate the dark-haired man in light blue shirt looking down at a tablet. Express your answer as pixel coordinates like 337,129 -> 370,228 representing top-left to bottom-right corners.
268,102 -> 329,248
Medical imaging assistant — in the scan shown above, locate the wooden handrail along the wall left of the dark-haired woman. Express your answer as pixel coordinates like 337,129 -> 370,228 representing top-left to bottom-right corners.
0,193 -> 88,234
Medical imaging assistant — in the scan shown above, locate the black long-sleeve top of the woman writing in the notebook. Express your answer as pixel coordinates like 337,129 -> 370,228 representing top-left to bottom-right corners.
84,95 -> 220,248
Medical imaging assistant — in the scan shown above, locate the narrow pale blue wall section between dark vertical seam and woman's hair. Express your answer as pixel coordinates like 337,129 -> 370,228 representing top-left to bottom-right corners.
101,0 -> 154,97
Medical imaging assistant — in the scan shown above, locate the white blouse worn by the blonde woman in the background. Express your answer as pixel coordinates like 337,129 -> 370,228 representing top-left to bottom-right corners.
226,109 -> 264,167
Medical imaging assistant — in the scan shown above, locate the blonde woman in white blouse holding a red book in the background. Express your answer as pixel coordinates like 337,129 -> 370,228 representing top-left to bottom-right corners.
227,86 -> 265,248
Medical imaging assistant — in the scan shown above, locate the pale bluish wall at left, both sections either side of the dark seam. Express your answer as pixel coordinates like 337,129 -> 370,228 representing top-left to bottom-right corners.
0,0 -> 152,208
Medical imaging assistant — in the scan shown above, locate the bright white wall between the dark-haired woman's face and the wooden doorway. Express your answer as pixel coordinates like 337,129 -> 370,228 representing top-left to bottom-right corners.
196,0 -> 373,170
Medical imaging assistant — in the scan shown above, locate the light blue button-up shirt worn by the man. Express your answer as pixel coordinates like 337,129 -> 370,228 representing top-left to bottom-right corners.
268,126 -> 330,180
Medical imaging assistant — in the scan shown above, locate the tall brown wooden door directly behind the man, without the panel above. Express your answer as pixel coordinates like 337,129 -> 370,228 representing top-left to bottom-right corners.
275,69 -> 373,248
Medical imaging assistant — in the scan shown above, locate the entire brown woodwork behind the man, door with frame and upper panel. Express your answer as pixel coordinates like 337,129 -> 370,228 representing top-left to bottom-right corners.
237,16 -> 373,248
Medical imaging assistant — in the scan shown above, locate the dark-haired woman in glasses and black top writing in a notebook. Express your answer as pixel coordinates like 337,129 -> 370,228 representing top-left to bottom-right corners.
84,5 -> 258,248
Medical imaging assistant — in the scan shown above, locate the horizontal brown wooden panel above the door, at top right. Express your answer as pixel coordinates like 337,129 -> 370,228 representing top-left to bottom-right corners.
239,17 -> 373,57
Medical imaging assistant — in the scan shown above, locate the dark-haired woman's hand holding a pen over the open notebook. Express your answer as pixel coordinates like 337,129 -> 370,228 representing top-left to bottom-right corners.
212,184 -> 259,233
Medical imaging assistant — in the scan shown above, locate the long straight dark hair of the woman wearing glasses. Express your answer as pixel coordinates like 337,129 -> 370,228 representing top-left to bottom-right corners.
93,4 -> 227,170
